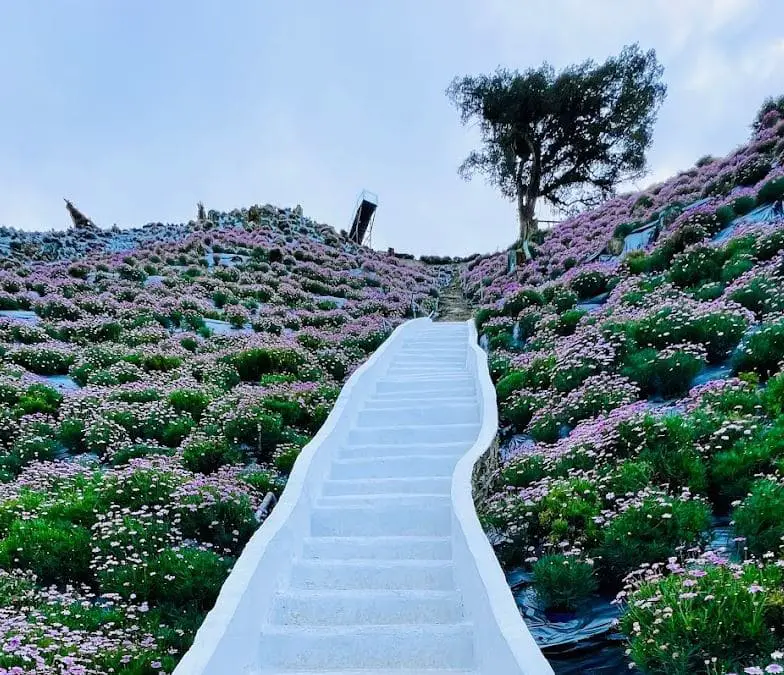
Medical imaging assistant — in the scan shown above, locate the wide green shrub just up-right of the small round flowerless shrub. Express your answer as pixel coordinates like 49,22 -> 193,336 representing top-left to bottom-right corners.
600,495 -> 711,582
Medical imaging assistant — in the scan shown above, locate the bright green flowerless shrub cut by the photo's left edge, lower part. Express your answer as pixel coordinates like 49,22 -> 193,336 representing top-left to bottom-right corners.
0,518 -> 92,585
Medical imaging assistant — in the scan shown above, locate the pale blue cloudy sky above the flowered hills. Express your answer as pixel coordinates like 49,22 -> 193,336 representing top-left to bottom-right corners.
0,0 -> 784,255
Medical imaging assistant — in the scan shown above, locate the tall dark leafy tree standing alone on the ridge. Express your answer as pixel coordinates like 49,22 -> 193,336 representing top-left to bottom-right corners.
447,44 -> 666,258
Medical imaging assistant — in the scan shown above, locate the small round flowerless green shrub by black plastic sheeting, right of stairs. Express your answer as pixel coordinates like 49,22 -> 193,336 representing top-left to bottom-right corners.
533,555 -> 599,612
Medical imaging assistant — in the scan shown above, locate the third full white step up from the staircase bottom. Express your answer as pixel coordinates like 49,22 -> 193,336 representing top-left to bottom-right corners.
291,559 -> 455,591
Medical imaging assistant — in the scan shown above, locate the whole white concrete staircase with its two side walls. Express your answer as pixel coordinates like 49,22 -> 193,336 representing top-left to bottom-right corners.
175,320 -> 552,675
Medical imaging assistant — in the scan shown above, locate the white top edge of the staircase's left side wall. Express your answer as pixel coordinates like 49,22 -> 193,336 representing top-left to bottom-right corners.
172,318 -> 430,675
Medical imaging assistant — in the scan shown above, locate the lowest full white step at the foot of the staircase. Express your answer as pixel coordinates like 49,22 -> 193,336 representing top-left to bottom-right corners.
259,624 -> 474,672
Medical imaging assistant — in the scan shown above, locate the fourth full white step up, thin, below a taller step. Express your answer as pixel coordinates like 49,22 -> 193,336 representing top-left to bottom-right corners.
302,536 -> 452,560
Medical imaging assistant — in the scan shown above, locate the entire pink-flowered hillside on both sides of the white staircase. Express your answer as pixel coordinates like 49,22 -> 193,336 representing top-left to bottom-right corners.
0,104 -> 784,675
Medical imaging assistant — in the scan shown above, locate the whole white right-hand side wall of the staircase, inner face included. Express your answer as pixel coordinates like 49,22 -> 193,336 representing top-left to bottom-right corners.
452,320 -> 553,675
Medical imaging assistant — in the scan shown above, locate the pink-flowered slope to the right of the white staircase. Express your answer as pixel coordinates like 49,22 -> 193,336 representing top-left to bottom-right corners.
463,112 -> 784,674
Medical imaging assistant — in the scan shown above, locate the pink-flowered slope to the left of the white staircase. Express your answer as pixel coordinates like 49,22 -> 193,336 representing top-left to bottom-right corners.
0,207 -> 440,675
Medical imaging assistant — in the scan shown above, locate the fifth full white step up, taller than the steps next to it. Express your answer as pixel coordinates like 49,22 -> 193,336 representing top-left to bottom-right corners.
310,502 -> 452,537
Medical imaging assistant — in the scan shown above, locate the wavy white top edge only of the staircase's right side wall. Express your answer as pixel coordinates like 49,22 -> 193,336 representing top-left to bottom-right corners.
452,320 -> 553,675
